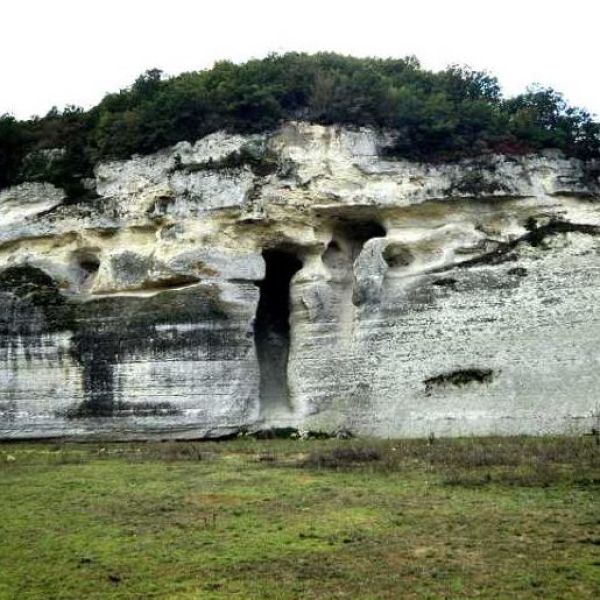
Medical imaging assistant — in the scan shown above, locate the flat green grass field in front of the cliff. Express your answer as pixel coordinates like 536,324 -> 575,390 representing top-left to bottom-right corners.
0,436 -> 600,600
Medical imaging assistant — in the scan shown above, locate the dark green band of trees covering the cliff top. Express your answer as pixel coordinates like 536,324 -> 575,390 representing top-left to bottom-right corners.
0,53 -> 600,197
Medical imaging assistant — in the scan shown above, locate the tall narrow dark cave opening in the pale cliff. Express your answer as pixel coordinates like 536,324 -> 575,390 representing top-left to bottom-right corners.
254,250 -> 302,416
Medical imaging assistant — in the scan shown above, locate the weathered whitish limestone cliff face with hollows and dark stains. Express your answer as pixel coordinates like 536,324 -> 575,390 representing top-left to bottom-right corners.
0,123 -> 600,439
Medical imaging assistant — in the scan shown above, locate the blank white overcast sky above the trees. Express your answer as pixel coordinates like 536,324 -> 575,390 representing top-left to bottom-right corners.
0,0 -> 600,118
